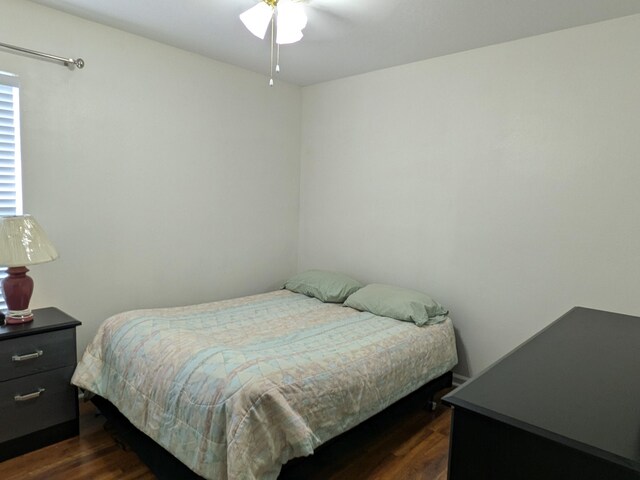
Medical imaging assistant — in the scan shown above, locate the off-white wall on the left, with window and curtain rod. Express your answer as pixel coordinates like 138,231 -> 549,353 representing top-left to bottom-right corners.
0,0 -> 301,351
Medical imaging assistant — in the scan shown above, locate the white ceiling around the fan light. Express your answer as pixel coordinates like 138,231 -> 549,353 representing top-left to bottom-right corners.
27,0 -> 640,85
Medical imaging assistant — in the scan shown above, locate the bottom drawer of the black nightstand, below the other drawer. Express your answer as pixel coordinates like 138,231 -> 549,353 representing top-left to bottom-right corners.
0,366 -> 77,442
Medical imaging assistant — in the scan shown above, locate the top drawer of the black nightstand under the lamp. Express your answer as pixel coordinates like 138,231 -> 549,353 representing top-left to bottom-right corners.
0,328 -> 76,382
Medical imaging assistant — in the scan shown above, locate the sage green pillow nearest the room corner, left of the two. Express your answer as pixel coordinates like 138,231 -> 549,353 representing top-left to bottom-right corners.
284,270 -> 363,303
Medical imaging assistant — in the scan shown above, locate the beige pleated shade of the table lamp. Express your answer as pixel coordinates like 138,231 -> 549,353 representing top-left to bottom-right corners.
0,215 -> 58,267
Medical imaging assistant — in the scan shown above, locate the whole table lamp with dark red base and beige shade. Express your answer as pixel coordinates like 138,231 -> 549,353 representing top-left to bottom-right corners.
0,215 -> 58,325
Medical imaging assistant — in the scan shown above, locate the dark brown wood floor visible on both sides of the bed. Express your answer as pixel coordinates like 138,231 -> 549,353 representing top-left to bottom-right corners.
0,395 -> 451,480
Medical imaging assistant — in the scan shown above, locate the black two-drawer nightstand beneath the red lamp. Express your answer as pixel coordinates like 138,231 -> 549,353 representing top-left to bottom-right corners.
0,307 -> 81,462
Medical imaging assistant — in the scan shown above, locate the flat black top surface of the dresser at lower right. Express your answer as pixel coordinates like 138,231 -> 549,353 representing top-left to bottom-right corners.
443,307 -> 640,471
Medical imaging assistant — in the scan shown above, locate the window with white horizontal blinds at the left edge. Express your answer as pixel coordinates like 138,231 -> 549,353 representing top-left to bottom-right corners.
0,72 -> 22,311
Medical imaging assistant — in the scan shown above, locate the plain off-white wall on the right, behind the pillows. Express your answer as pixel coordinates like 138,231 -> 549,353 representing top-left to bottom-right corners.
299,15 -> 640,375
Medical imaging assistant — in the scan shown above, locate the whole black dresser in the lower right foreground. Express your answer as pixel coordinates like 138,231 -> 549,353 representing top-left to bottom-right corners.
443,307 -> 640,480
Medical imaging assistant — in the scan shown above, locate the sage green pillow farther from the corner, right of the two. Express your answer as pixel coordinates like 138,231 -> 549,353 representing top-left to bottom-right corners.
344,283 -> 449,326
